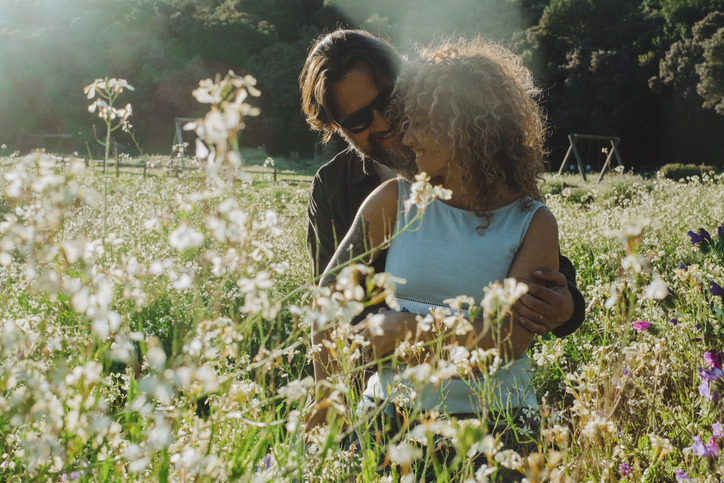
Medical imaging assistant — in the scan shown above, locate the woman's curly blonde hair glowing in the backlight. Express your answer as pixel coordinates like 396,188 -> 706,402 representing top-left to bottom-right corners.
387,37 -> 545,226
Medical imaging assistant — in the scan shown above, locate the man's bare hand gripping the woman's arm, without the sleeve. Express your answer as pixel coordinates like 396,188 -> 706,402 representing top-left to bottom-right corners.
513,269 -> 573,335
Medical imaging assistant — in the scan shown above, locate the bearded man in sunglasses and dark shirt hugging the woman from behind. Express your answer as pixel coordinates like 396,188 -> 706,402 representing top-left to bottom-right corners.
299,30 -> 585,337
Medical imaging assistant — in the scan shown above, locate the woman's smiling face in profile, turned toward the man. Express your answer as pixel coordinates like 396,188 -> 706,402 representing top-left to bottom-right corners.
402,120 -> 453,180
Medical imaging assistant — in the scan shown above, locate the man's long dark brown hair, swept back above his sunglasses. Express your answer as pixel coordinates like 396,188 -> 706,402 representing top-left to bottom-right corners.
299,30 -> 402,143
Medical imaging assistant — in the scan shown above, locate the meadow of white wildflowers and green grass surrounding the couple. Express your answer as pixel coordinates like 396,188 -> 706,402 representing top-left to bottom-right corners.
0,73 -> 724,482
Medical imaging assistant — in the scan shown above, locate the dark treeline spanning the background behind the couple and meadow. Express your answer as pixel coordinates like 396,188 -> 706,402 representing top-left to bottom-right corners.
0,0 -> 724,169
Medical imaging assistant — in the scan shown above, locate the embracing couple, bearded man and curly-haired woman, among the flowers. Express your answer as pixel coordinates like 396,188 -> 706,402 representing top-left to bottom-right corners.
300,30 -> 584,476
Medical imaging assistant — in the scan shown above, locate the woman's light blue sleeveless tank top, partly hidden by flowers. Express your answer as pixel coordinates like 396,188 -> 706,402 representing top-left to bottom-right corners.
364,179 -> 544,414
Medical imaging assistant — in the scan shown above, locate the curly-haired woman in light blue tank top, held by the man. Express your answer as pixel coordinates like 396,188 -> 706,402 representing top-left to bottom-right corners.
308,39 -> 558,436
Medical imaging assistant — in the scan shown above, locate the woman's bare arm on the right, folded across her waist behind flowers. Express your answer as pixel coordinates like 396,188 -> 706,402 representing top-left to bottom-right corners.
358,207 -> 558,359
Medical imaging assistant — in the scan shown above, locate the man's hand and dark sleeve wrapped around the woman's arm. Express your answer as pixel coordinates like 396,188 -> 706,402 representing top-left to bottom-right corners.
514,255 -> 586,337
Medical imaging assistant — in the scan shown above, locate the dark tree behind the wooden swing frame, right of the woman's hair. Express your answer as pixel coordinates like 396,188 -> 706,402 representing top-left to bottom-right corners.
515,0 -> 656,166
